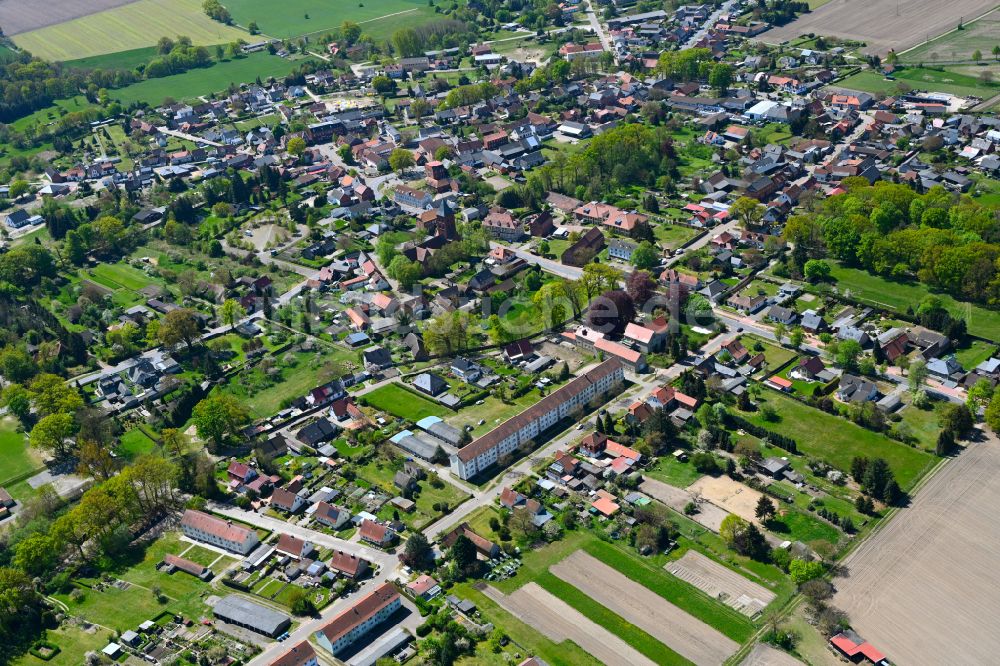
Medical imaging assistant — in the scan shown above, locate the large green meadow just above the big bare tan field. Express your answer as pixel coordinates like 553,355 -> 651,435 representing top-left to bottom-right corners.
742,390 -> 934,490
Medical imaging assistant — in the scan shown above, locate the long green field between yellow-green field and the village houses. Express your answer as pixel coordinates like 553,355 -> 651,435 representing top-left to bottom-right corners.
108,52 -> 314,105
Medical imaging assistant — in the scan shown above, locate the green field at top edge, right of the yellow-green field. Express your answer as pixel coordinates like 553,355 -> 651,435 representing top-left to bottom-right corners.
224,0 -> 427,38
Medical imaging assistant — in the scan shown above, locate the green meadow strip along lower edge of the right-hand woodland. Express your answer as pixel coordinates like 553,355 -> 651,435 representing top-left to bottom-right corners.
830,262 -> 1000,341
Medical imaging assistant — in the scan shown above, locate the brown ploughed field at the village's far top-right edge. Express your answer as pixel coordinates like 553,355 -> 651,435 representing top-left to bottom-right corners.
762,0 -> 995,56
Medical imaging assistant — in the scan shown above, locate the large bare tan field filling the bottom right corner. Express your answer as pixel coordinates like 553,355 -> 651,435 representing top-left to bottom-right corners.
834,436 -> 1000,666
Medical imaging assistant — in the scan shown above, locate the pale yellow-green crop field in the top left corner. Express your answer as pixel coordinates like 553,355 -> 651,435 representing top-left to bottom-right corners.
12,0 -> 248,60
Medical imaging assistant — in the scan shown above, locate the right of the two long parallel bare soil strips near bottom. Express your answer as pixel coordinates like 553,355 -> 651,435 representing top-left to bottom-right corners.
549,550 -> 739,666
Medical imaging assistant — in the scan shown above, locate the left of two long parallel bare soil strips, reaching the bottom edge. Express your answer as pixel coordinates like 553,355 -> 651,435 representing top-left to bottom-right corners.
484,583 -> 656,666
